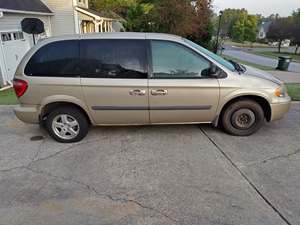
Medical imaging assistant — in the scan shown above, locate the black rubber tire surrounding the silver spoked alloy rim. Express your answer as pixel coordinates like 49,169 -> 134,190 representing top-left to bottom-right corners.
45,106 -> 89,143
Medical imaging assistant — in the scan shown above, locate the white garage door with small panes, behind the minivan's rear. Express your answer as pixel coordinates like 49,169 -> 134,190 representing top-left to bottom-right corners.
0,31 -> 30,81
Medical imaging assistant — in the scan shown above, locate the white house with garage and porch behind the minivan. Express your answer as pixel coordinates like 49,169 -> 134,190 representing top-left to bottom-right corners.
0,0 -> 123,87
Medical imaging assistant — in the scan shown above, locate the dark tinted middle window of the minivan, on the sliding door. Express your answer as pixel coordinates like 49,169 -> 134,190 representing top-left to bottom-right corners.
80,40 -> 147,79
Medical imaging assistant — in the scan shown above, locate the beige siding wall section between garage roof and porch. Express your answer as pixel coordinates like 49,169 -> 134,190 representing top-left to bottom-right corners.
43,0 -> 76,36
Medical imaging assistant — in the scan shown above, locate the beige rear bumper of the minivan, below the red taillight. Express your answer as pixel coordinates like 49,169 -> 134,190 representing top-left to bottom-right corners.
14,105 -> 40,124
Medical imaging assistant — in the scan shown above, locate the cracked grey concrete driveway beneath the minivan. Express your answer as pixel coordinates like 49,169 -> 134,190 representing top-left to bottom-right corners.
0,104 -> 300,225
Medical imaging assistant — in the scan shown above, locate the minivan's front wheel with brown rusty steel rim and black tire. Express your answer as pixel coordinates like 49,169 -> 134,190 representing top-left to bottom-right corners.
221,100 -> 265,136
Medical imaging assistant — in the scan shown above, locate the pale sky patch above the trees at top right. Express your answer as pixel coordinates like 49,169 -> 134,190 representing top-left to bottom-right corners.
213,0 -> 300,16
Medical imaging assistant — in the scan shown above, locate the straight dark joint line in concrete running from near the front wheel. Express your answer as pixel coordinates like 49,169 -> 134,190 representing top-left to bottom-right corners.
200,127 -> 292,225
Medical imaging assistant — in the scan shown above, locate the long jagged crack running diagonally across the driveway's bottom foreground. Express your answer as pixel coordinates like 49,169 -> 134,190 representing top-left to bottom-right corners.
25,167 -> 184,225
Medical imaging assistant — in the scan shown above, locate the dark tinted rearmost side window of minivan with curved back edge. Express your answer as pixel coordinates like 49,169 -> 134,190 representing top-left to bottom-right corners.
25,40 -> 80,77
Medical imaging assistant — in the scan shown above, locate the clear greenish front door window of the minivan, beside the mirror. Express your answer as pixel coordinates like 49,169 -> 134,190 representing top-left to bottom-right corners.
151,41 -> 211,79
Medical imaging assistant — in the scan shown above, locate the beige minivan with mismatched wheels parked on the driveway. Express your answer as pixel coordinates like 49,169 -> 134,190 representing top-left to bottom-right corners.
14,33 -> 291,143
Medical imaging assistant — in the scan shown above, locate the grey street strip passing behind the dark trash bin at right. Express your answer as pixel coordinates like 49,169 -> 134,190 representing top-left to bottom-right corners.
223,46 -> 300,73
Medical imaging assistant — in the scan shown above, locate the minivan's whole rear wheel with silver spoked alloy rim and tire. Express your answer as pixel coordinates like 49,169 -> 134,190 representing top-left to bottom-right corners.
46,107 -> 89,143
